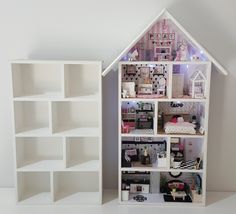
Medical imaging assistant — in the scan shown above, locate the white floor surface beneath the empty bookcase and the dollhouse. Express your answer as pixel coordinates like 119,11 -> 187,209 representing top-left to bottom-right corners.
0,188 -> 236,214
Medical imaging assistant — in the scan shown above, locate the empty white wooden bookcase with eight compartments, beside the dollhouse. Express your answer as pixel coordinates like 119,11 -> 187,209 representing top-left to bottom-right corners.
12,60 -> 102,204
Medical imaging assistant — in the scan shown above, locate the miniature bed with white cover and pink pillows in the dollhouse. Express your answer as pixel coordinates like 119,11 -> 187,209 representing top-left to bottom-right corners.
164,114 -> 196,134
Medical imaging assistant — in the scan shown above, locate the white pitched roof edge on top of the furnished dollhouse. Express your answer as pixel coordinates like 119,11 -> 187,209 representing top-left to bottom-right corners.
102,9 -> 228,76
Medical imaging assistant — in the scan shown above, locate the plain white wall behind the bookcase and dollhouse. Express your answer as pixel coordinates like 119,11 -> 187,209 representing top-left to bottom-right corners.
0,0 -> 236,191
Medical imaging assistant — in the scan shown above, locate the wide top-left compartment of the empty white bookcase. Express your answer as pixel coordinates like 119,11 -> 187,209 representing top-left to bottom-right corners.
12,63 -> 62,97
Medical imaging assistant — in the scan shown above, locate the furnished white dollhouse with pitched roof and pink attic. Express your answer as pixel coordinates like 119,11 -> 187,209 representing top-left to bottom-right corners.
103,10 -> 227,206
